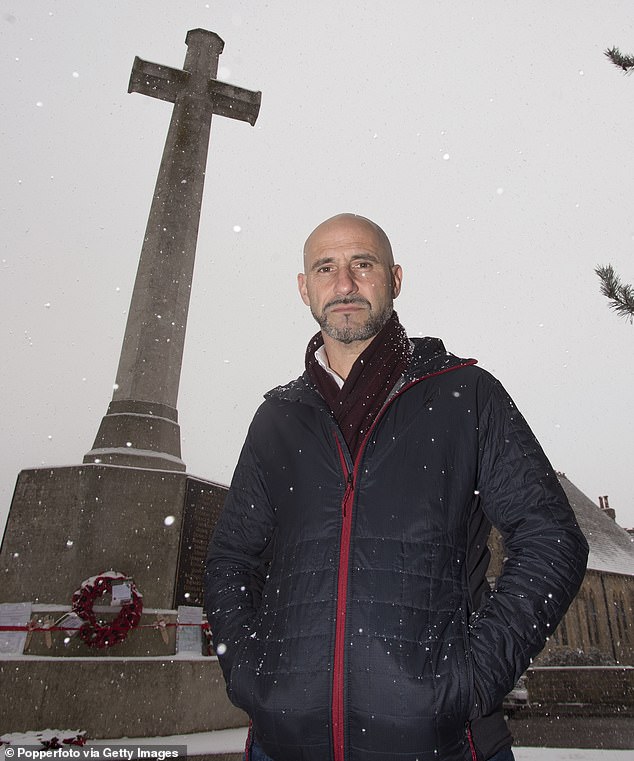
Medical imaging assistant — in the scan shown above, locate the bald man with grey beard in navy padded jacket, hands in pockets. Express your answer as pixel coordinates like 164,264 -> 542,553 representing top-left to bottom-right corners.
206,214 -> 587,761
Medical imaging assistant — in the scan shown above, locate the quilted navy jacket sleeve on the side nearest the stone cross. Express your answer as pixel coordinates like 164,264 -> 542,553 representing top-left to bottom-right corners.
205,422 -> 275,683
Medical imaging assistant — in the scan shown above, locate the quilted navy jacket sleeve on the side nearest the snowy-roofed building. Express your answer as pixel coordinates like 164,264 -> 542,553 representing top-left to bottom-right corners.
469,373 -> 588,715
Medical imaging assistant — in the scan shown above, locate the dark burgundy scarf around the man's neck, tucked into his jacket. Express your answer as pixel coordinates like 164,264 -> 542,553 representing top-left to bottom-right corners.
306,312 -> 411,458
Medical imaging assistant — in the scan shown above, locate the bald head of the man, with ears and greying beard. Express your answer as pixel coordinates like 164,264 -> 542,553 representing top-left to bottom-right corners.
297,216 -> 402,344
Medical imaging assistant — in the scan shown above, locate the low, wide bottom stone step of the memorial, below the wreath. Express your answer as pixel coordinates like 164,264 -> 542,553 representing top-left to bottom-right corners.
0,657 -> 248,739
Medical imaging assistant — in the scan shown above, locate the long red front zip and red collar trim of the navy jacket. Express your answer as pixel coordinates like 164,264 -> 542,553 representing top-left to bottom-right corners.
331,359 -> 477,761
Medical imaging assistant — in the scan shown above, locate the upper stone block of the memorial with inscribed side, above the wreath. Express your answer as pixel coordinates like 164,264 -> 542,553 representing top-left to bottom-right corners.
0,464 -> 226,610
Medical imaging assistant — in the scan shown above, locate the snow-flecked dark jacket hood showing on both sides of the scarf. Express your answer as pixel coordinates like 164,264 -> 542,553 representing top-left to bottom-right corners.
264,336 -> 477,404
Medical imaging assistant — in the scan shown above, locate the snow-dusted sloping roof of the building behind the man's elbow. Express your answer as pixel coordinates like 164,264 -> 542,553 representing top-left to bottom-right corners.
557,473 -> 634,576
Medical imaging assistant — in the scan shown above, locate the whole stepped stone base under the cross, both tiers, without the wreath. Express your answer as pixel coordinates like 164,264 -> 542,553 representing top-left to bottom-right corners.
0,463 -> 235,739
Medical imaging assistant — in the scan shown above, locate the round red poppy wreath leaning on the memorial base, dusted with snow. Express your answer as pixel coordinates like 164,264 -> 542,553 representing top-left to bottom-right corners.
72,571 -> 143,648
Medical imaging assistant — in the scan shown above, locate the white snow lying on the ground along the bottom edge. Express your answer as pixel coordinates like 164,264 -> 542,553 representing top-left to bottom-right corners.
0,728 -> 634,761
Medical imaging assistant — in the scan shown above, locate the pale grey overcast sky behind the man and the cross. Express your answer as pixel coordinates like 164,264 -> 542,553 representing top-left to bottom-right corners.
0,0 -> 634,526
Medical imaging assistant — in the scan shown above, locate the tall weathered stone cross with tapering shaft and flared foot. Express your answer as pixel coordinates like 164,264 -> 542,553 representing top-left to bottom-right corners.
84,29 -> 261,470
